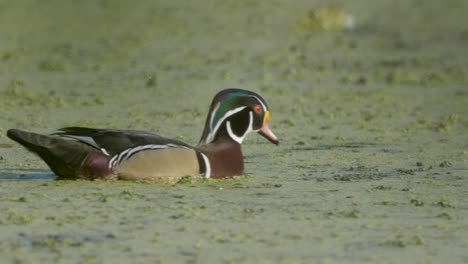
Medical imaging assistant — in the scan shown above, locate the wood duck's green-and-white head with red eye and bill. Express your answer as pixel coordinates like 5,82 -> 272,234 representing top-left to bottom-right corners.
199,89 -> 279,145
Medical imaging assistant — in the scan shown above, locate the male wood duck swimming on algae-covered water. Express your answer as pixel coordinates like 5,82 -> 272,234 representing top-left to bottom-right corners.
7,89 -> 279,180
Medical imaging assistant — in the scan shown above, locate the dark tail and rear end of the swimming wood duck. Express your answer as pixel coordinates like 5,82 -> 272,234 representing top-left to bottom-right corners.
7,129 -> 95,179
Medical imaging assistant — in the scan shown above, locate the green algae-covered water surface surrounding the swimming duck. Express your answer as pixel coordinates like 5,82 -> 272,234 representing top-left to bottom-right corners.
0,0 -> 468,263
